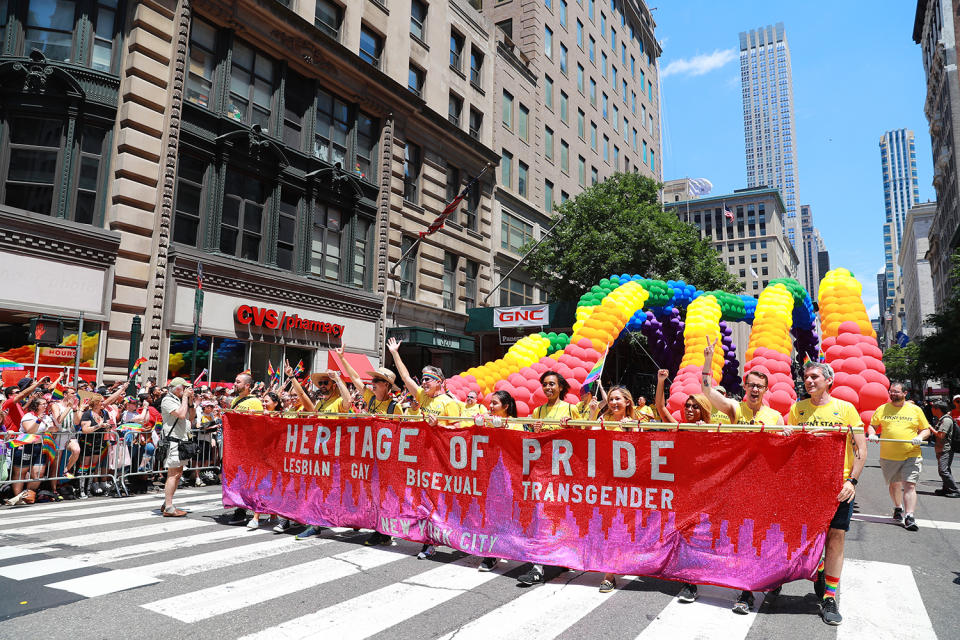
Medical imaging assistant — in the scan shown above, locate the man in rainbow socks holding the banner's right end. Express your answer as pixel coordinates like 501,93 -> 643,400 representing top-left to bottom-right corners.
783,362 -> 867,626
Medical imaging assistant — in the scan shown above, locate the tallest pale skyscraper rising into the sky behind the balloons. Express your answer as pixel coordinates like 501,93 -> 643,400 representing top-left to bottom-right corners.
740,22 -> 806,278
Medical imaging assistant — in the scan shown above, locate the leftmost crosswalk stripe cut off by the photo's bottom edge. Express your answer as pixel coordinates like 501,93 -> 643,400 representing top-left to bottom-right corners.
241,557 -> 501,640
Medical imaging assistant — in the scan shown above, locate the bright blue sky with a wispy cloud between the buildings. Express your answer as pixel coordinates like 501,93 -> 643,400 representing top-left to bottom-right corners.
648,0 -> 936,317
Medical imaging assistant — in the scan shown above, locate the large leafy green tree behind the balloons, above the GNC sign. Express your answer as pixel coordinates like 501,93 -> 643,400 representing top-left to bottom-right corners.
525,173 -> 740,300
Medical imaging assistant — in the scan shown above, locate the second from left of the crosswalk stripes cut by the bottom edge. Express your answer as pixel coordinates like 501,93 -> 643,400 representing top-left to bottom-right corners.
439,572 -> 611,640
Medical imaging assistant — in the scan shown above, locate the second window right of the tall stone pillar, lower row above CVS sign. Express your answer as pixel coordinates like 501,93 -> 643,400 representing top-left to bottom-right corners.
220,168 -> 269,261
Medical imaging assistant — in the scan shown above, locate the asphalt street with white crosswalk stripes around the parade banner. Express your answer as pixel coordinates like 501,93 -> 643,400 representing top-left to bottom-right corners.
0,445 -> 960,640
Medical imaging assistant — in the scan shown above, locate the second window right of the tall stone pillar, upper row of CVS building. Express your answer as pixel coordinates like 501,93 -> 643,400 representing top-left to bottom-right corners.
227,40 -> 276,130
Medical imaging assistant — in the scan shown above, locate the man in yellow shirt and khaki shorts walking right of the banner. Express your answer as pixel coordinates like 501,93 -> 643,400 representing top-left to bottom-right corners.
867,382 -> 930,531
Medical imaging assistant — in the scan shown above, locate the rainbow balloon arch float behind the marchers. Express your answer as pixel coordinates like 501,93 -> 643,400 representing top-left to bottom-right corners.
447,269 -> 889,423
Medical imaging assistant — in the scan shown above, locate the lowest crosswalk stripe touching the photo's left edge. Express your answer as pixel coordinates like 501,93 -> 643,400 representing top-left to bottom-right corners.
0,527 -> 266,580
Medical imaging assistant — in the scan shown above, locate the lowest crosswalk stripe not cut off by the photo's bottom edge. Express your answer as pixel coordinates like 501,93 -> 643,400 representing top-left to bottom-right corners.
141,547 -> 410,622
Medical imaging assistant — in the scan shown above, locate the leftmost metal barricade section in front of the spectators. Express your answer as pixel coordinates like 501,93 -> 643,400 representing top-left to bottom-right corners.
0,430 -> 127,502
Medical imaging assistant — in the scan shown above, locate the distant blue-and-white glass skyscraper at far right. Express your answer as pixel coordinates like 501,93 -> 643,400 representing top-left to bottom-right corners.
880,129 -> 920,312
